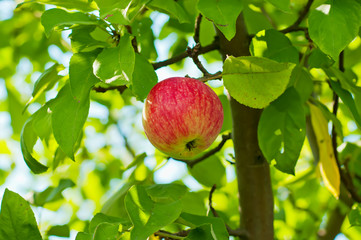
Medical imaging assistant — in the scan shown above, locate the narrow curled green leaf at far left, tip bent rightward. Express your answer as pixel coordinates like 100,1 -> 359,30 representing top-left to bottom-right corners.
20,117 -> 48,174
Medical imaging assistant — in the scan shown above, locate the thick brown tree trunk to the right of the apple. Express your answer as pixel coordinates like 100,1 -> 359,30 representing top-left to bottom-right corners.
219,15 -> 273,240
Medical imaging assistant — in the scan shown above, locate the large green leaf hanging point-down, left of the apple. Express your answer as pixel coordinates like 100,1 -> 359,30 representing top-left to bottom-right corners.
51,83 -> 90,160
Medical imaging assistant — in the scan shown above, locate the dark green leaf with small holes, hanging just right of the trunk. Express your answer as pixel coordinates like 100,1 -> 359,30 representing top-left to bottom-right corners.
258,87 -> 306,174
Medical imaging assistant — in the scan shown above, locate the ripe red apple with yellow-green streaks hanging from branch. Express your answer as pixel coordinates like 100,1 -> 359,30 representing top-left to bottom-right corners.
143,77 -> 223,159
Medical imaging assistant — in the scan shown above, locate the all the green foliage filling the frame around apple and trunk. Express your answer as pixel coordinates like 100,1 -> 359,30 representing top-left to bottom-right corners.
0,0 -> 361,239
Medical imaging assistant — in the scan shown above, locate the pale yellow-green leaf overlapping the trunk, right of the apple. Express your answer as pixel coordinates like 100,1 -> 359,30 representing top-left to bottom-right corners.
222,56 -> 295,108
